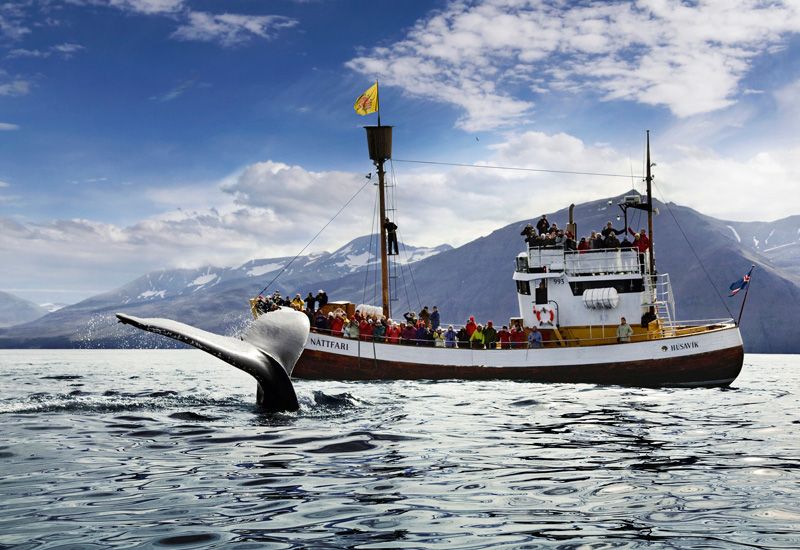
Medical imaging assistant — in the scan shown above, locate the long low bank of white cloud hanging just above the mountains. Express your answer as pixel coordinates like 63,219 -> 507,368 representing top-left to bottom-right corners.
0,132 -> 800,306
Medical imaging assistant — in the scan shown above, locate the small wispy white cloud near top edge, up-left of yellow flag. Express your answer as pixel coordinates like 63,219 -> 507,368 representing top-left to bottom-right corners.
172,11 -> 298,47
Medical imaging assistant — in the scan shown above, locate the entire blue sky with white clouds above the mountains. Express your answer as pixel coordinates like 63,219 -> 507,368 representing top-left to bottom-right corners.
0,0 -> 800,303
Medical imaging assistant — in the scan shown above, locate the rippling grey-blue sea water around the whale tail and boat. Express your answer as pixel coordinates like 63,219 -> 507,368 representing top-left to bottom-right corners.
0,350 -> 800,548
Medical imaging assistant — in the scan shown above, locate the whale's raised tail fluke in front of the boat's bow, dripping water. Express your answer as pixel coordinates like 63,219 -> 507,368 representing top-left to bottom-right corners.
117,308 -> 310,411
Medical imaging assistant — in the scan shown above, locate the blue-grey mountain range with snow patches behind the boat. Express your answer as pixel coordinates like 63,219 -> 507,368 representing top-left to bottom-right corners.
0,201 -> 800,353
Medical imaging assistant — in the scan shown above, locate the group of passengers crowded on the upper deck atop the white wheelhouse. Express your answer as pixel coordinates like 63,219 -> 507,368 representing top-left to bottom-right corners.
520,215 -> 650,254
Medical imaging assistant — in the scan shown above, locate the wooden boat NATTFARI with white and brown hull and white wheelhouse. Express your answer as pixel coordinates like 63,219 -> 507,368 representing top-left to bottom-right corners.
278,125 -> 744,387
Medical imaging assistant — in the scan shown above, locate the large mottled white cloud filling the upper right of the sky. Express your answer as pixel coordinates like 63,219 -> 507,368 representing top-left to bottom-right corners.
347,0 -> 800,131
